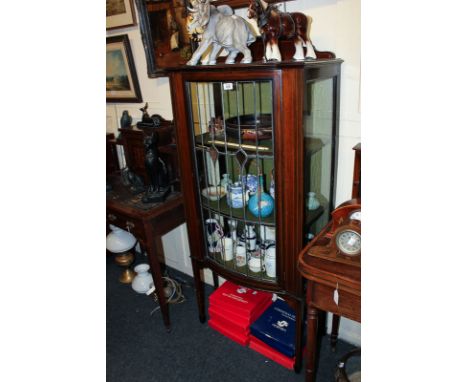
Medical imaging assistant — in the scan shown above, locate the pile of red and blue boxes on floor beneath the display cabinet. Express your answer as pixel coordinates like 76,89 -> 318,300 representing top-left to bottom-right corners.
208,281 -> 296,369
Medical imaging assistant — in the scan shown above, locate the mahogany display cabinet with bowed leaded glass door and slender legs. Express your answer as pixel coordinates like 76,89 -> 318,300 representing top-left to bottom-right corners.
167,59 -> 342,371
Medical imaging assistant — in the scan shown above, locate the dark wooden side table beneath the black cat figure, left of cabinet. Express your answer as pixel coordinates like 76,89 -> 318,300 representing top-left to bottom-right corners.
106,176 -> 185,330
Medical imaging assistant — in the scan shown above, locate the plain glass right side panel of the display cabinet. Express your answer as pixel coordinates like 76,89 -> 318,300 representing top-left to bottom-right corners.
304,78 -> 334,240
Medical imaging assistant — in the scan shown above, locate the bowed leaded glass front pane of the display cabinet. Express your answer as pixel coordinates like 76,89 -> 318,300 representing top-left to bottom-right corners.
186,80 -> 276,283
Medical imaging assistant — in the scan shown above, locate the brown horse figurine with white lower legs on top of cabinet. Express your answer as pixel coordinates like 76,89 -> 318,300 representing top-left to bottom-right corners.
247,0 -> 317,61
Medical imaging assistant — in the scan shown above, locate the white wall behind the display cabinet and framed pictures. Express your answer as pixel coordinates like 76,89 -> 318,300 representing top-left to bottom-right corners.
106,0 -> 361,344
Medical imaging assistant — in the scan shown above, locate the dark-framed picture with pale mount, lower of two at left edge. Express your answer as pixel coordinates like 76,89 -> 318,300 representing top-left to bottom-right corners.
106,35 -> 142,102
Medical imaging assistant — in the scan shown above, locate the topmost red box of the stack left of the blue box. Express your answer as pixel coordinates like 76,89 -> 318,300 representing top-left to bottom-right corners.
209,281 -> 272,318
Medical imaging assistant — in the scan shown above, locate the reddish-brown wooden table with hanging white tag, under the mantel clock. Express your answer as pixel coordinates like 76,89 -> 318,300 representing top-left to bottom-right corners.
298,222 -> 361,382
